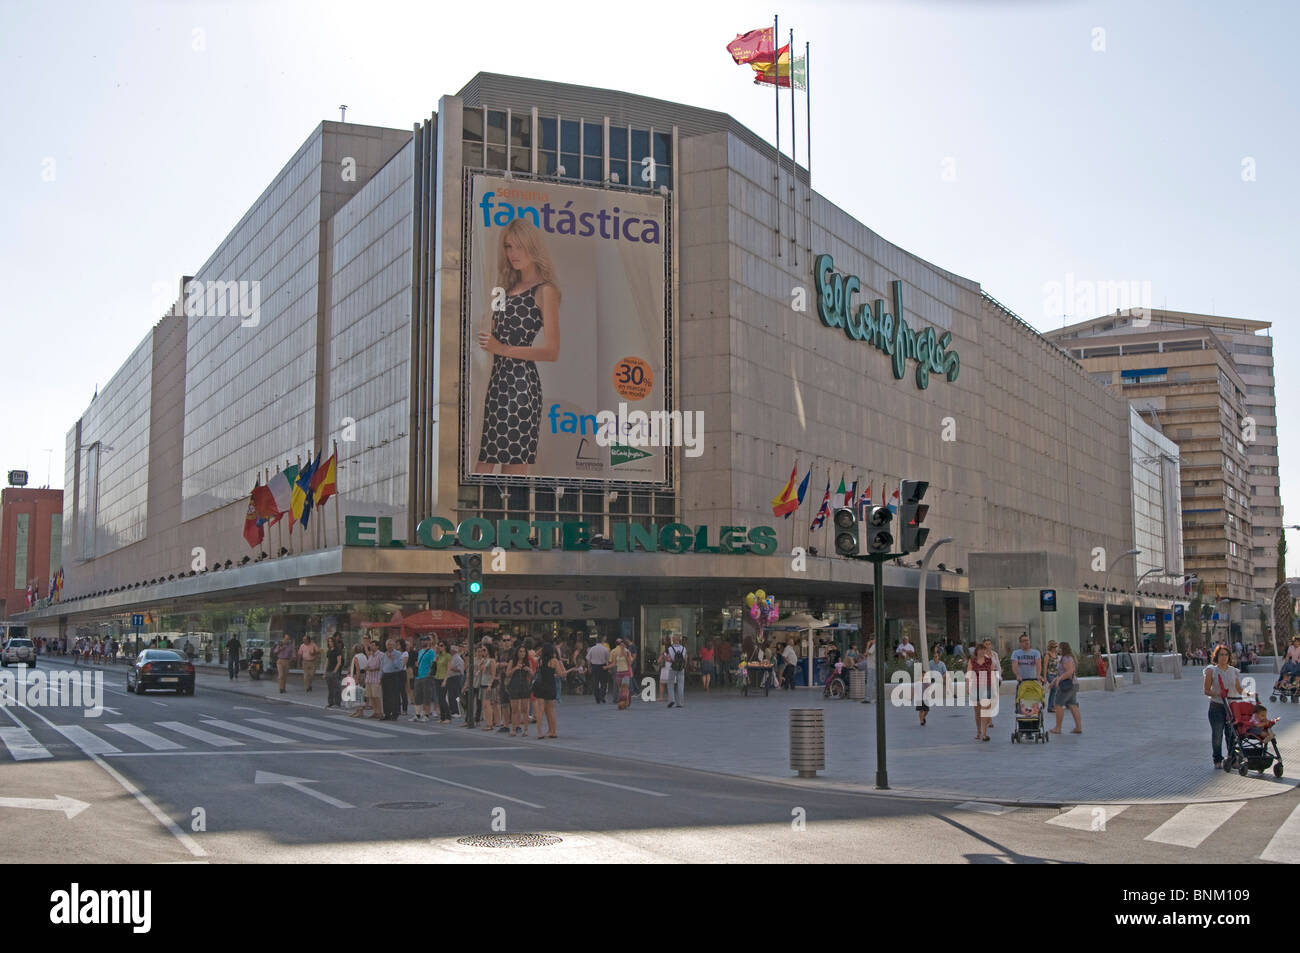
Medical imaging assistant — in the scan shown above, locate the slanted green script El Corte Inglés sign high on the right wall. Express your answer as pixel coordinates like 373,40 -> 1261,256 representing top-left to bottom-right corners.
813,255 -> 962,390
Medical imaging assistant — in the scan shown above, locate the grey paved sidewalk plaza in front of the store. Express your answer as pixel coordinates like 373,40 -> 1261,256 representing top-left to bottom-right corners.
189,666 -> 1300,805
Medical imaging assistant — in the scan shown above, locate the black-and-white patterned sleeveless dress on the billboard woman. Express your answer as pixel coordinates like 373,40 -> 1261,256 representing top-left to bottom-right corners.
478,285 -> 542,463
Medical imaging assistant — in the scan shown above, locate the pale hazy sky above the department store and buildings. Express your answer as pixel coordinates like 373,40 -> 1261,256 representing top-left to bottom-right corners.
0,0 -> 1300,551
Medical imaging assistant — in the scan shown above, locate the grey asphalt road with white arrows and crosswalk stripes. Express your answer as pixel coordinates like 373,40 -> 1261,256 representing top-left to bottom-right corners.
0,659 -> 1300,863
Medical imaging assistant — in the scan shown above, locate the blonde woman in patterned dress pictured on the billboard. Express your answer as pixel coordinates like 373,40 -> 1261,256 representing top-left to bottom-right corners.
475,218 -> 560,475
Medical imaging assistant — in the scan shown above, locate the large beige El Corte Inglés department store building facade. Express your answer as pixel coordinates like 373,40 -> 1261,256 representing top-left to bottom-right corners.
17,73 -> 1170,658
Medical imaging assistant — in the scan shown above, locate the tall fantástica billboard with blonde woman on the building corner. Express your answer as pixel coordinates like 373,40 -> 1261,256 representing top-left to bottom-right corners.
460,173 -> 680,486
